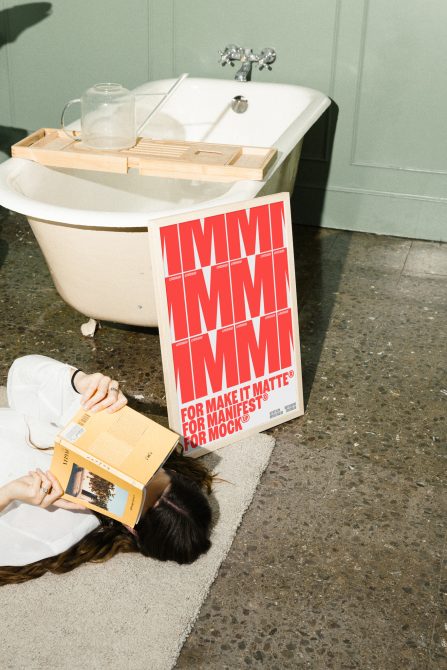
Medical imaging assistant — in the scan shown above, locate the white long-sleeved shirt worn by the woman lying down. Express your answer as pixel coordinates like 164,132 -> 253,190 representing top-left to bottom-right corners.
0,355 -> 100,566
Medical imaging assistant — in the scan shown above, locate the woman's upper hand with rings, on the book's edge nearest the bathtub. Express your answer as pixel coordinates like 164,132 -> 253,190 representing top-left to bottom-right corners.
74,371 -> 127,412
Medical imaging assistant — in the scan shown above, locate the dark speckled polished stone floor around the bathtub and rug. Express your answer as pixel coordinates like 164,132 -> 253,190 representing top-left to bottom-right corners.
0,210 -> 447,670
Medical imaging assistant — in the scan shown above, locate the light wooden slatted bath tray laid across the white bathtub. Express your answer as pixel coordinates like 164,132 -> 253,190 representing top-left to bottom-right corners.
11,128 -> 277,181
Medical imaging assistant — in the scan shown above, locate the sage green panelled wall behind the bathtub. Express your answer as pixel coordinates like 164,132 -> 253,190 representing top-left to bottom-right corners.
0,0 -> 447,240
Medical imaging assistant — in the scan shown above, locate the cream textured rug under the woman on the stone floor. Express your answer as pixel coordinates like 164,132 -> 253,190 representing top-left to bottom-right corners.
0,388 -> 275,670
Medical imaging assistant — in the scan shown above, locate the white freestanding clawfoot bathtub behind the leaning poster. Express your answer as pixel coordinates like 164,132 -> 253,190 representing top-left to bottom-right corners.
0,78 -> 330,326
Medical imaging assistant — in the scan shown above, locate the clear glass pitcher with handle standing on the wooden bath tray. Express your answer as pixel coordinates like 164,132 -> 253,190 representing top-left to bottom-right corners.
61,83 -> 136,151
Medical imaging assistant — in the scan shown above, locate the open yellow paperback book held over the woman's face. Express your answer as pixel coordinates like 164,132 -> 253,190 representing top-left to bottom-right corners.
50,407 -> 179,528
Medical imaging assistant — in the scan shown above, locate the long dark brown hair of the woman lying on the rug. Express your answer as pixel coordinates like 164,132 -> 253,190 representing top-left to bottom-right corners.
0,452 -> 213,586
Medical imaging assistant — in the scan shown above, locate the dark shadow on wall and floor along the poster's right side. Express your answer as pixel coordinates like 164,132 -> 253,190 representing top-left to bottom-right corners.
291,101 -> 349,407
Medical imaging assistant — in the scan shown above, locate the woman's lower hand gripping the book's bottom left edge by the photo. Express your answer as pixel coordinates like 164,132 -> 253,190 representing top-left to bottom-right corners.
5,468 -> 85,509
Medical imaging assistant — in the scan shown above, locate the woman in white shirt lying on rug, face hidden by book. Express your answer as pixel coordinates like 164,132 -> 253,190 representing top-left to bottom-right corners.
0,355 -> 213,584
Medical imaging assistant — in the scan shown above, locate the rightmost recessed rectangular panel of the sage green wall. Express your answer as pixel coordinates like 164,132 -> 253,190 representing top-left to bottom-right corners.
352,0 -> 447,174
